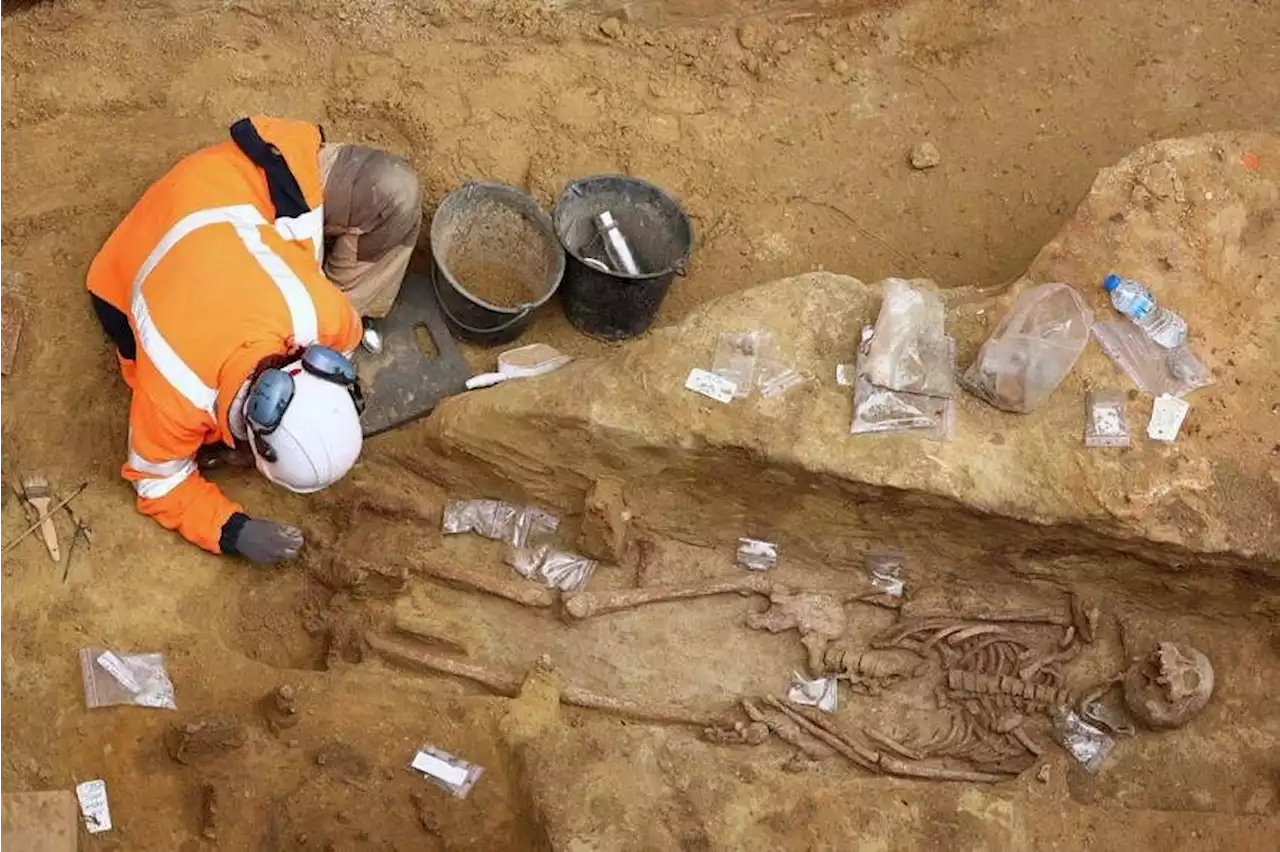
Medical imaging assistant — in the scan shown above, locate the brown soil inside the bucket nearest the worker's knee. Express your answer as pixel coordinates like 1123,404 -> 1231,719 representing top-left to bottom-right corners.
444,200 -> 556,308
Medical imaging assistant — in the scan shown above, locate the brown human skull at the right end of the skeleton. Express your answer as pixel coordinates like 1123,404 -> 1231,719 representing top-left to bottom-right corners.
1124,642 -> 1213,729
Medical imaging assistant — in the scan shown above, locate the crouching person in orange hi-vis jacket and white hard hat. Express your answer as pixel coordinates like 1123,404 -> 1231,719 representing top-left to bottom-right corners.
88,118 -> 422,564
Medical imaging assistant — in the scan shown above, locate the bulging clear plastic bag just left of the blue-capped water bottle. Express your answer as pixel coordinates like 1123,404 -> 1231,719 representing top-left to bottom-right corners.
960,284 -> 1093,414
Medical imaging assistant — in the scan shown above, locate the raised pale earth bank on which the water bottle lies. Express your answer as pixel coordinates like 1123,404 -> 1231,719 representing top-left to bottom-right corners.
407,134 -> 1280,606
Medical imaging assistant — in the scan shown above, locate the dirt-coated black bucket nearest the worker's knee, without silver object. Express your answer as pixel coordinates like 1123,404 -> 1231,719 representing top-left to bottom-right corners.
431,183 -> 564,345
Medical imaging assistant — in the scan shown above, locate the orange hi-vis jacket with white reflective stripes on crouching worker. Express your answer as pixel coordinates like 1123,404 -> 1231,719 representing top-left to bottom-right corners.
88,118 -> 361,553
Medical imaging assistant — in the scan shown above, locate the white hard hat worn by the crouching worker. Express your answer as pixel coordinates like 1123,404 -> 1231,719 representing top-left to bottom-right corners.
250,365 -> 364,494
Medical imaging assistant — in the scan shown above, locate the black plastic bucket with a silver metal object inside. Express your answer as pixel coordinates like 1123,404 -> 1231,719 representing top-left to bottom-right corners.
554,174 -> 694,340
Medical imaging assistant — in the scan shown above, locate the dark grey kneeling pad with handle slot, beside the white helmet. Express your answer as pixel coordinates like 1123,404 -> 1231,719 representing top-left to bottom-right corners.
356,272 -> 471,438
